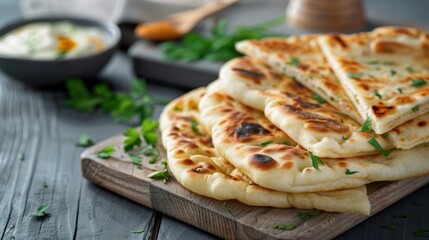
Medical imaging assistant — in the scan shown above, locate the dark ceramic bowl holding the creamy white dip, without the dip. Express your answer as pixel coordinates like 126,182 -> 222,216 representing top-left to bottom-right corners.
0,17 -> 121,87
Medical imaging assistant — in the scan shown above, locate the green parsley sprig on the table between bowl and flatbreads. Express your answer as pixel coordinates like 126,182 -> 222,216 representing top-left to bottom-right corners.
64,79 -> 167,122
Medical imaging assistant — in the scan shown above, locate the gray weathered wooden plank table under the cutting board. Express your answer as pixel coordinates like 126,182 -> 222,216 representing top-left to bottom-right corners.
0,0 -> 429,239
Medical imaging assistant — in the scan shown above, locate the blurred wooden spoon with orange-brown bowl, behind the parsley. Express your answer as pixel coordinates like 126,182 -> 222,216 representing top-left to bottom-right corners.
135,0 -> 239,41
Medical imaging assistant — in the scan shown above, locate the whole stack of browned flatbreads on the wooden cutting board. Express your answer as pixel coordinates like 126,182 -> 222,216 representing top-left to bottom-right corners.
161,27 -> 429,214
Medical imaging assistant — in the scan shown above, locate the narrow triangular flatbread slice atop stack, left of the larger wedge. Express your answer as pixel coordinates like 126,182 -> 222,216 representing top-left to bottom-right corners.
235,35 -> 365,123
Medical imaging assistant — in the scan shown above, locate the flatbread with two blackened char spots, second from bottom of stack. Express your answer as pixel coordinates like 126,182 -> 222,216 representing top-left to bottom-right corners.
199,82 -> 429,192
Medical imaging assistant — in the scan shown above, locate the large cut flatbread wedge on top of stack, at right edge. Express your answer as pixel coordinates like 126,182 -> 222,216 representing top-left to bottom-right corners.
319,27 -> 429,134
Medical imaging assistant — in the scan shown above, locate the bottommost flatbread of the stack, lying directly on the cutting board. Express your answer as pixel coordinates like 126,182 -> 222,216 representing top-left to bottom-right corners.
161,88 -> 370,215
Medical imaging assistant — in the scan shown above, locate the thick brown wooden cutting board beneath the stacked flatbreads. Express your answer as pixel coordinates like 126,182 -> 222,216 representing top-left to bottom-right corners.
81,136 -> 429,239
